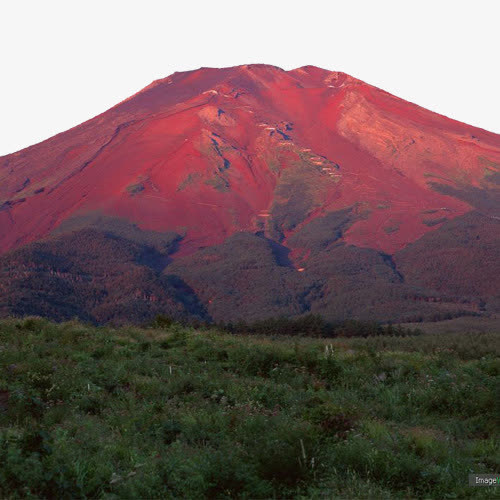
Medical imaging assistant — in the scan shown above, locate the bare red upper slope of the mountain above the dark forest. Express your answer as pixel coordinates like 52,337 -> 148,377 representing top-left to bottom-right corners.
0,65 -> 500,253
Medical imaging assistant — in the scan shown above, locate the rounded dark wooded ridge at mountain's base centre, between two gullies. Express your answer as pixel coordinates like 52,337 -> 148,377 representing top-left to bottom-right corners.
169,232 -> 308,321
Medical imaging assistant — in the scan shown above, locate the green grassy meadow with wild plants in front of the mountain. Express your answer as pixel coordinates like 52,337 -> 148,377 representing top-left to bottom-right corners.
0,318 -> 500,499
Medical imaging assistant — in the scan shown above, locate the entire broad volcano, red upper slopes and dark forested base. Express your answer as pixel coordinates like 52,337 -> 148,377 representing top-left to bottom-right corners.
0,64 -> 500,323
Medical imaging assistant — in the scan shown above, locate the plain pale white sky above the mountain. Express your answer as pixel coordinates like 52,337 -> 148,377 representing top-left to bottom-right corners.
0,0 -> 500,156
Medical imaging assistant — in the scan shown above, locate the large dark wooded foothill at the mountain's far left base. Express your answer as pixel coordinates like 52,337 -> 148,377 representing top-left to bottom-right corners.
0,226 -> 209,324
